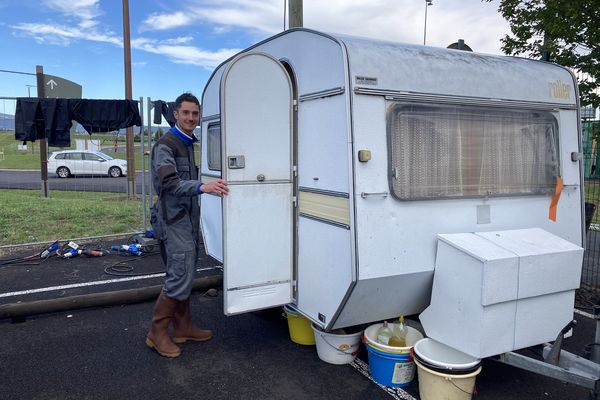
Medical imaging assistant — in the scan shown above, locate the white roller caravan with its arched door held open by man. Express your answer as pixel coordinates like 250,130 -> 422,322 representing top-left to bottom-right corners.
200,29 -> 584,356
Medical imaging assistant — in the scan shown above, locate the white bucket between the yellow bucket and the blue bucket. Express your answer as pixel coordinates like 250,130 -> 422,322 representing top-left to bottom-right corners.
311,324 -> 362,364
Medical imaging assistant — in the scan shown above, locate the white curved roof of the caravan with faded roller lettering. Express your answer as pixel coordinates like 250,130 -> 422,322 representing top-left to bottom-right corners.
204,28 -> 577,115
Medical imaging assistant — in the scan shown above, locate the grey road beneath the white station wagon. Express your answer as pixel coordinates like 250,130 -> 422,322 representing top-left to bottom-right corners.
0,170 -> 150,194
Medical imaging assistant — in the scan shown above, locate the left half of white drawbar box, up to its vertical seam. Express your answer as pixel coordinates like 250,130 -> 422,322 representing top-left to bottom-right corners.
419,233 -> 518,358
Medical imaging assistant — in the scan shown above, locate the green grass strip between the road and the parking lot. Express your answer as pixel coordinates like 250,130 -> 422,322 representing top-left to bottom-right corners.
0,189 -> 142,245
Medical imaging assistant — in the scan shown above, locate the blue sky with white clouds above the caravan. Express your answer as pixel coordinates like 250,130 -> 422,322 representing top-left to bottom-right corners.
0,0 -> 510,114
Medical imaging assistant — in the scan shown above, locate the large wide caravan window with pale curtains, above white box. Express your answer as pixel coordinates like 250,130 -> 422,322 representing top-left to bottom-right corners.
387,103 -> 559,200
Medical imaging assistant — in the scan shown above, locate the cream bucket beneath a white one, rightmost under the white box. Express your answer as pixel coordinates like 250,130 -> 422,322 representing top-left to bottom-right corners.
414,358 -> 481,400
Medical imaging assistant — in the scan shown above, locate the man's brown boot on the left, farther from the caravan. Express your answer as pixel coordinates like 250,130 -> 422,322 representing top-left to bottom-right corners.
146,293 -> 181,357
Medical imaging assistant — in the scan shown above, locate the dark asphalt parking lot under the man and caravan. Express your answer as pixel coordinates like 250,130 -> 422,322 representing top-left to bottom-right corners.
0,241 -> 595,400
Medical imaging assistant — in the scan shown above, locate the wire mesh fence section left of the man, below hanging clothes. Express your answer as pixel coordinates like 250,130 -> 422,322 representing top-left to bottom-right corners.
0,97 -> 169,248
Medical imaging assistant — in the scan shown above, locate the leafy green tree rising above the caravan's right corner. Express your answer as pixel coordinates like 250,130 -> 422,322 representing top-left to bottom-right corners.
486,0 -> 600,107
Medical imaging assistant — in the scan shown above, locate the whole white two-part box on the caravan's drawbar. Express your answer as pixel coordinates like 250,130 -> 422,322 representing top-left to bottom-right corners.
420,228 -> 583,358
